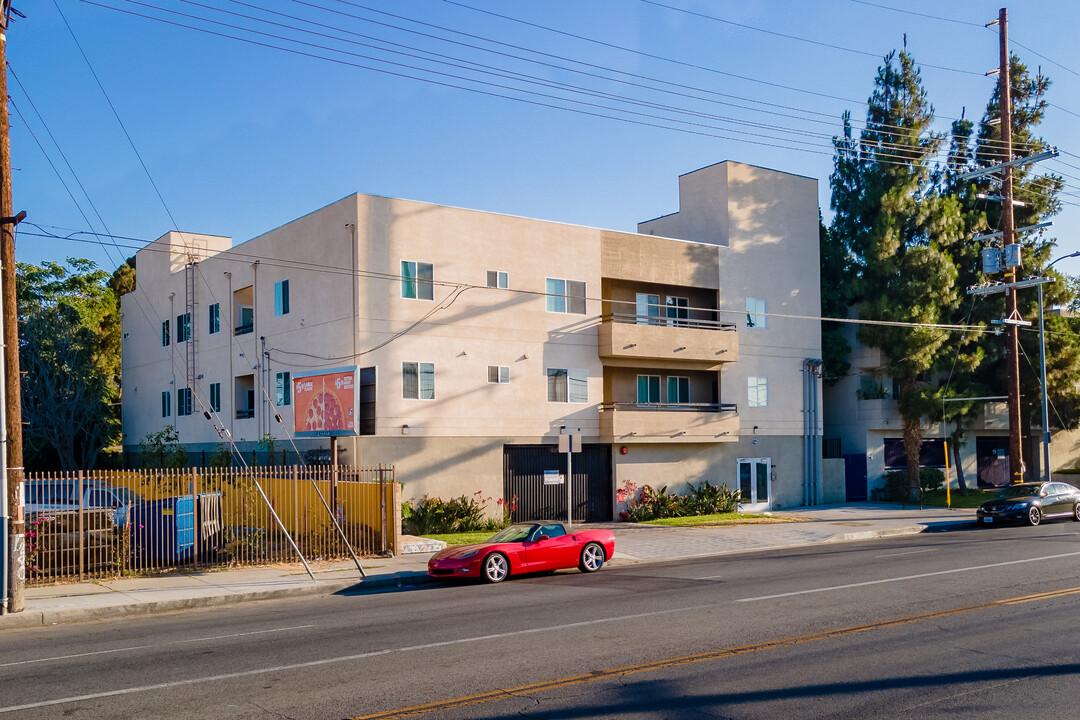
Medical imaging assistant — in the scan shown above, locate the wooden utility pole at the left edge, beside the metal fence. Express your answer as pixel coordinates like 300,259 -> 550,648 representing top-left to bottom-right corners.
0,0 -> 26,612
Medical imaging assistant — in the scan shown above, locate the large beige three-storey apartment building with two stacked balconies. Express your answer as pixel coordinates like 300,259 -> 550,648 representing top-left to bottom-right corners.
122,162 -> 835,520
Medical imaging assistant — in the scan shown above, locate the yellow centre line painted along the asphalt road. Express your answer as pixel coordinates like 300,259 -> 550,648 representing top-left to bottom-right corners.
352,587 -> 1080,720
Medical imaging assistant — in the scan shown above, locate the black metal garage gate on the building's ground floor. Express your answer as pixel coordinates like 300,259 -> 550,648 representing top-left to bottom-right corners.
502,445 -> 615,522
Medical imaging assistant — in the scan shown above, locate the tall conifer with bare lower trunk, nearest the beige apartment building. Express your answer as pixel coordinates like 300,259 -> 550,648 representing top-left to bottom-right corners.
829,49 -> 963,497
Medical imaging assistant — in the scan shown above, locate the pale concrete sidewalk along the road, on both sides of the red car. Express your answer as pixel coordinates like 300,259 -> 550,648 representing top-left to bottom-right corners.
0,503 -> 975,630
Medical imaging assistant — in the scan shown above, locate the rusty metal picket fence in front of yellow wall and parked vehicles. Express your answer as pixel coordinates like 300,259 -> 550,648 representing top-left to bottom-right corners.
25,465 -> 401,585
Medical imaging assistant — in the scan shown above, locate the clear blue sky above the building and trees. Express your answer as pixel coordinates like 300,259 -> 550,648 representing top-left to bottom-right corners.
8,0 -> 1080,273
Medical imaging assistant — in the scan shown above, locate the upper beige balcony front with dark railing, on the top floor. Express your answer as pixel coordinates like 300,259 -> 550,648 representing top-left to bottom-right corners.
597,313 -> 739,370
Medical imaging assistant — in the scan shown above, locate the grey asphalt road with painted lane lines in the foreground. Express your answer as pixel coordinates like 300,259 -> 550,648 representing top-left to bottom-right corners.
0,522 -> 1080,720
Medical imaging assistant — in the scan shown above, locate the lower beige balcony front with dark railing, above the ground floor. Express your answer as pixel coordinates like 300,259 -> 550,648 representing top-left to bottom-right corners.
600,403 -> 739,444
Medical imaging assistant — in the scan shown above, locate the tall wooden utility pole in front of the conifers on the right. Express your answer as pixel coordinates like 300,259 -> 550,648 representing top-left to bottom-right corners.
998,8 -> 1027,483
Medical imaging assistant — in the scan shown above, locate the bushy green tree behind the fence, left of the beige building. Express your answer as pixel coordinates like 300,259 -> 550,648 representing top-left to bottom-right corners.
17,258 -> 120,470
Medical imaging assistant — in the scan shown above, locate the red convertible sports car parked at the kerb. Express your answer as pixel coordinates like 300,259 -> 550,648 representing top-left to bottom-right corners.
428,522 -> 615,583
